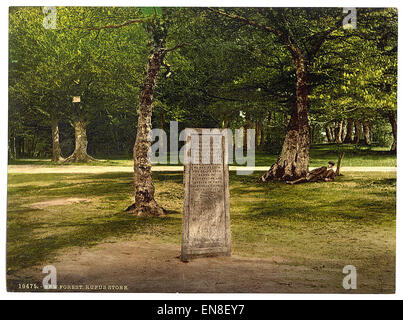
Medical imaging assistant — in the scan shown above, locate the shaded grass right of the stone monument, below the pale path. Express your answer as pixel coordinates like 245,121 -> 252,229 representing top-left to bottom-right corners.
231,173 -> 396,224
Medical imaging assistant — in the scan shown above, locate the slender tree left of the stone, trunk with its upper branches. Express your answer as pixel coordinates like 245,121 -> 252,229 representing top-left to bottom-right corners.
84,8 -> 188,216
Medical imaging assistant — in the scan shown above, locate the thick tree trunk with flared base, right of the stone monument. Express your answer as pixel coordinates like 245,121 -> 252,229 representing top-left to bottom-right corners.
261,53 -> 310,181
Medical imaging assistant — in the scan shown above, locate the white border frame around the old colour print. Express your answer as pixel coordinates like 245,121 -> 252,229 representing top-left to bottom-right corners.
0,0 -> 403,300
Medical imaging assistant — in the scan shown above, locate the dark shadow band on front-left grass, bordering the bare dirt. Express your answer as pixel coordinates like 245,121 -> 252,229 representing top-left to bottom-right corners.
7,213 -> 181,274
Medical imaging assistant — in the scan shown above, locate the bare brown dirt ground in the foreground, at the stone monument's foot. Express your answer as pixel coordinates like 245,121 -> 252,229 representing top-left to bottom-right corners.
8,240 -> 386,293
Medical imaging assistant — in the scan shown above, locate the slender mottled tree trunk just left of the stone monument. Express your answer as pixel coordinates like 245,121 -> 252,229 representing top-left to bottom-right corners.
126,47 -> 166,216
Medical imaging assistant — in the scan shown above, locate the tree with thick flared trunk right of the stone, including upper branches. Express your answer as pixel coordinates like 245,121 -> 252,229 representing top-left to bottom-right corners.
211,8 -> 394,181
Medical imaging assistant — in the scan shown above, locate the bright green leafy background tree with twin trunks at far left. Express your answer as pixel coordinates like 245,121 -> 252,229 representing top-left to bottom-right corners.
10,7 -> 146,162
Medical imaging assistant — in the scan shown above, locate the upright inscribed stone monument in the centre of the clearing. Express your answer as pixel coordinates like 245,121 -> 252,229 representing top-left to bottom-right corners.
181,129 -> 231,261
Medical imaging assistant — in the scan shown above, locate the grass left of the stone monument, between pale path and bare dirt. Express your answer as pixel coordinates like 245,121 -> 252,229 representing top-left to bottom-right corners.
7,173 -> 186,272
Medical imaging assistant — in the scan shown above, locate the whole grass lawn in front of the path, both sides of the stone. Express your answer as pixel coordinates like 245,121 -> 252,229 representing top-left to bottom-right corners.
7,172 -> 396,291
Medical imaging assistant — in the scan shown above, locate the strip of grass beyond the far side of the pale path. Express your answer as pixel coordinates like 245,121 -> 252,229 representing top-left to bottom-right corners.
9,144 -> 396,167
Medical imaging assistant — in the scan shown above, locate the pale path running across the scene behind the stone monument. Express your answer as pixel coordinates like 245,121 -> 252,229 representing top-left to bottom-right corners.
8,165 -> 397,174
